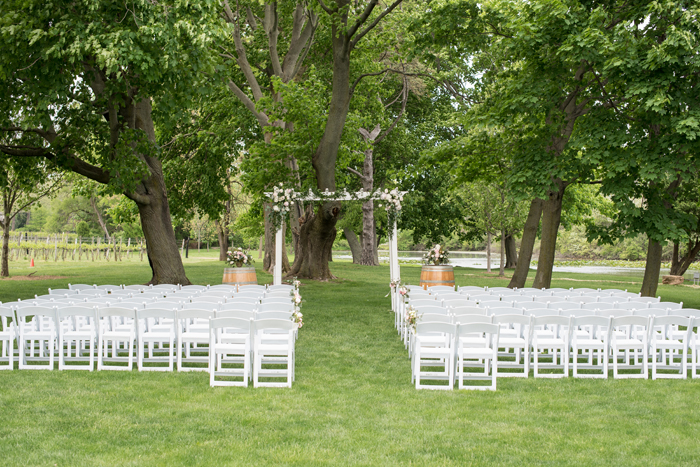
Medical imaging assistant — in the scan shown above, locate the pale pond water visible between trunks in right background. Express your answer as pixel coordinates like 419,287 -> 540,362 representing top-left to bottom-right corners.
333,251 -> 694,281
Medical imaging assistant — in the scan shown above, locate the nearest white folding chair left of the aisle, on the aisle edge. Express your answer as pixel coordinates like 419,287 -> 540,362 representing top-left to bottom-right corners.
253,319 -> 297,388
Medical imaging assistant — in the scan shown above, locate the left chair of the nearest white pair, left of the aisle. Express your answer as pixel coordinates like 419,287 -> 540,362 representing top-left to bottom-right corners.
209,317 -> 253,387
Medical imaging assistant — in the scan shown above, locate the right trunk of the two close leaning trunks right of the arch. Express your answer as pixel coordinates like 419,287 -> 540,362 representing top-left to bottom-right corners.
532,179 -> 566,289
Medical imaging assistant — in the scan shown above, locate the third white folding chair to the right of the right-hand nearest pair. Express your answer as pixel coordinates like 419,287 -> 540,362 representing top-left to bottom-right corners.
569,315 -> 611,378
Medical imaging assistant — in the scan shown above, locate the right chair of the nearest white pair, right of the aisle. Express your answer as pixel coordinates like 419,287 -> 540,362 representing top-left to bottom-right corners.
456,323 -> 501,391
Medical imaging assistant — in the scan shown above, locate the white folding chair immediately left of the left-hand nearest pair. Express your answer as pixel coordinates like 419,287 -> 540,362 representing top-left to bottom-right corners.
177,309 -> 214,371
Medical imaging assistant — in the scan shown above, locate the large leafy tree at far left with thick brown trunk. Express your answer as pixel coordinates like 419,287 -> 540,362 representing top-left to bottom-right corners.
0,0 -> 214,284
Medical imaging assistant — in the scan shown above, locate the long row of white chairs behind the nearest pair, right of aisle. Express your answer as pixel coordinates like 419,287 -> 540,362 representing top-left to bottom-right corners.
412,315 -> 700,388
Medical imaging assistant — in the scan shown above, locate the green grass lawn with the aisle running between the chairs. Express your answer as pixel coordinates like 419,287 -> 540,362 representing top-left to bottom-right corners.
0,253 -> 700,466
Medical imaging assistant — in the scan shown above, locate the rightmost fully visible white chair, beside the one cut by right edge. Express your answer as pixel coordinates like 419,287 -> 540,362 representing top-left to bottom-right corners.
649,315 -> 692,380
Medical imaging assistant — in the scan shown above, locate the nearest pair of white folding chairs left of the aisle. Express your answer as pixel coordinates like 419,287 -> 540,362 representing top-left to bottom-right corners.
209,317 -> 297,388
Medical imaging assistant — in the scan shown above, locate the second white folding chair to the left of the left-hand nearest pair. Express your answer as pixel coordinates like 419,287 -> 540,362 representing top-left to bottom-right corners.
136,308 -> 178,371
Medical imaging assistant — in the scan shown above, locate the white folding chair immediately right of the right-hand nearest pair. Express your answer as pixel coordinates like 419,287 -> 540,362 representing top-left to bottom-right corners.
493,314 -> 532,378
